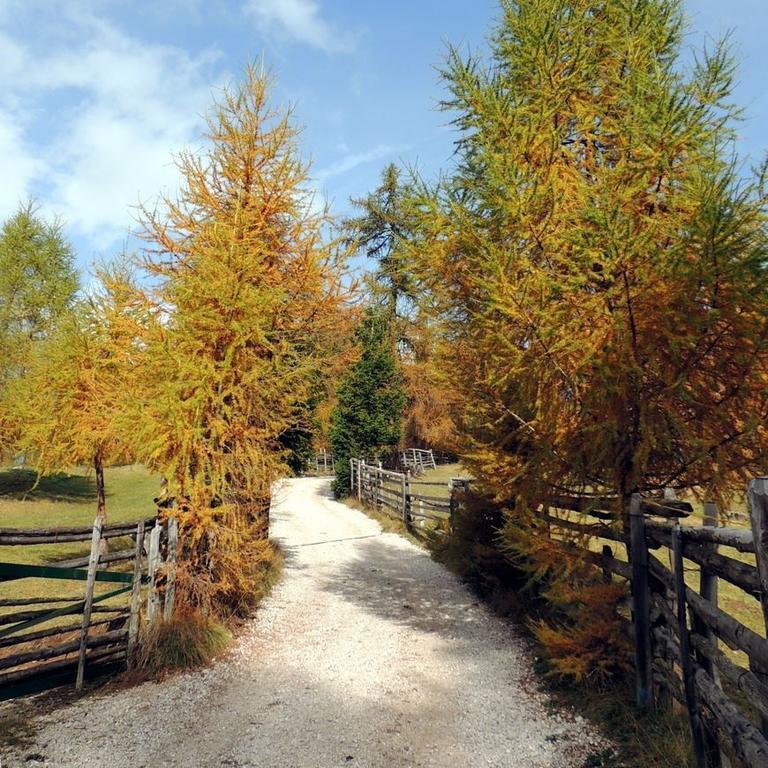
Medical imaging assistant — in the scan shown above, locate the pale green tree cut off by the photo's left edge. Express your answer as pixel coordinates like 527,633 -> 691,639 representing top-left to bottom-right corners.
0,203 -> 78,450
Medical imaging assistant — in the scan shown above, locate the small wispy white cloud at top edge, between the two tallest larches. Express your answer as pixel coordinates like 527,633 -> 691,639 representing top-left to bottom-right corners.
244,0 -> 356,53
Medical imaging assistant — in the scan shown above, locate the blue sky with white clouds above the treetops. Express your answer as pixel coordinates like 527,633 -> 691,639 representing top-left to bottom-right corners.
0,0 -> 768,268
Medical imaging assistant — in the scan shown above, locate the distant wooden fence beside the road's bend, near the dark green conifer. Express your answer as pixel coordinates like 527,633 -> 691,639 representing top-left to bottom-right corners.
350,459 -> 468,534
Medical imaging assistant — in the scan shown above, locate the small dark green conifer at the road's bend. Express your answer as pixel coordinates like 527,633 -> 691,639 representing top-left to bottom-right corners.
331,309 -> 406,496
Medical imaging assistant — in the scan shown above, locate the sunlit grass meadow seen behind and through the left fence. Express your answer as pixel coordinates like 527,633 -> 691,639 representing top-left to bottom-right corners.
0,466 -> 159,612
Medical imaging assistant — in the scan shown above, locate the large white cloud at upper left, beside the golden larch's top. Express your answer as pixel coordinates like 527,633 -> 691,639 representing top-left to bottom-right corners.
0,8 -> 222,250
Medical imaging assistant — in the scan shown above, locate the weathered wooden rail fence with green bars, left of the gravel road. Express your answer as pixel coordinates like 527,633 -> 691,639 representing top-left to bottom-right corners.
0,517 -> 177,700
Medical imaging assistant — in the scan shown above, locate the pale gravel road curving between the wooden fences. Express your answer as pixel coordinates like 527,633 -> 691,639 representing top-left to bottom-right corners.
2,479 -> 606,768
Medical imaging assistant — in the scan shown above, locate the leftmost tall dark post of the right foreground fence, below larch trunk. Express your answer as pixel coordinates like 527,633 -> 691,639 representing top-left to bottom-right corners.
629,493 -> 653,709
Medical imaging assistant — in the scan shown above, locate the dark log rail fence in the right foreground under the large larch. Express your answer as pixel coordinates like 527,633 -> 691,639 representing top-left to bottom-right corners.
541,486 -> 768,768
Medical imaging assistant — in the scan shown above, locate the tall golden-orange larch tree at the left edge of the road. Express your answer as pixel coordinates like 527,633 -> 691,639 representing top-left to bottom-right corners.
136,67 -> 346,612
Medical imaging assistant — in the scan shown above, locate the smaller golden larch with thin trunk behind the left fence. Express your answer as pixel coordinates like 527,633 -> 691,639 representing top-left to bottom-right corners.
7,269 -> 146,520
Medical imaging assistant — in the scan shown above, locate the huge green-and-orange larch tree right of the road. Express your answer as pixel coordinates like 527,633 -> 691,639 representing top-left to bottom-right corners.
413,0 -> 768,510
